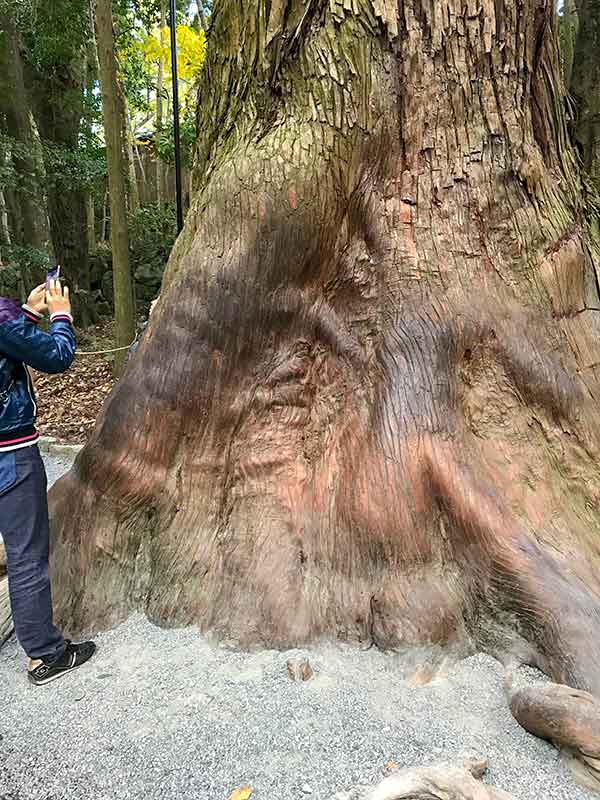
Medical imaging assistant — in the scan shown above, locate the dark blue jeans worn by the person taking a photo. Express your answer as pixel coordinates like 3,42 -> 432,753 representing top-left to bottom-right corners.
0,446 -> 66,659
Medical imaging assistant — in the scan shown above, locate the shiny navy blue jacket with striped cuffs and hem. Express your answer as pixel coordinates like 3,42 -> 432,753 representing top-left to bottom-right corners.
0,297 -> 75,451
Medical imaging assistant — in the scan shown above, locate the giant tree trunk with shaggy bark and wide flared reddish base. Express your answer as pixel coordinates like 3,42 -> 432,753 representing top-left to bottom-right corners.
52,0 -> 600,693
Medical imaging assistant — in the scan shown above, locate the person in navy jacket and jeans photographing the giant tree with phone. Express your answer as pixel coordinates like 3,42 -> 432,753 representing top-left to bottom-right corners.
0,281 -> 96,686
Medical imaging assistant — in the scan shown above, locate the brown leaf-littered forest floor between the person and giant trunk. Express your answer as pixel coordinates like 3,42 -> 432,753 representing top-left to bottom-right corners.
34,320 -> 115,444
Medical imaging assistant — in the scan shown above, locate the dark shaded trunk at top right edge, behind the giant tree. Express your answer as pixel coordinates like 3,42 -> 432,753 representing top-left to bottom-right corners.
570,0 -> 600,192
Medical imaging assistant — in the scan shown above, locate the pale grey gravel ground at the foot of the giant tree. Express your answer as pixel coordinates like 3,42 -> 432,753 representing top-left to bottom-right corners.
0,456 -> 592,800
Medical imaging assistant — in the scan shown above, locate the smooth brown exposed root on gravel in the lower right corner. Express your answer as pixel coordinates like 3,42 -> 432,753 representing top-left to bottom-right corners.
508,683 -> 600,792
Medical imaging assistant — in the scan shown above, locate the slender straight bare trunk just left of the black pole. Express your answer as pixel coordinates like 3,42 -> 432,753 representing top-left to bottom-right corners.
96,0 -> 135,373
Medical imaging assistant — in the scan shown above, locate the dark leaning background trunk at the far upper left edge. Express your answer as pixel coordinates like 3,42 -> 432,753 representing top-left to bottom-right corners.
0,10 -> 50,250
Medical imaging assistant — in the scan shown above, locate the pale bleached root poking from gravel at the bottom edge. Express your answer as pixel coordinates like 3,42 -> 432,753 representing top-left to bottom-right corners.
331,757 -> 513,800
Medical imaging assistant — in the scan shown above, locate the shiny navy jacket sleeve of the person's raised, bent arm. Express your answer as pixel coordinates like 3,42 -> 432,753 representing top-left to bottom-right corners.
0,314 -> 75,375
